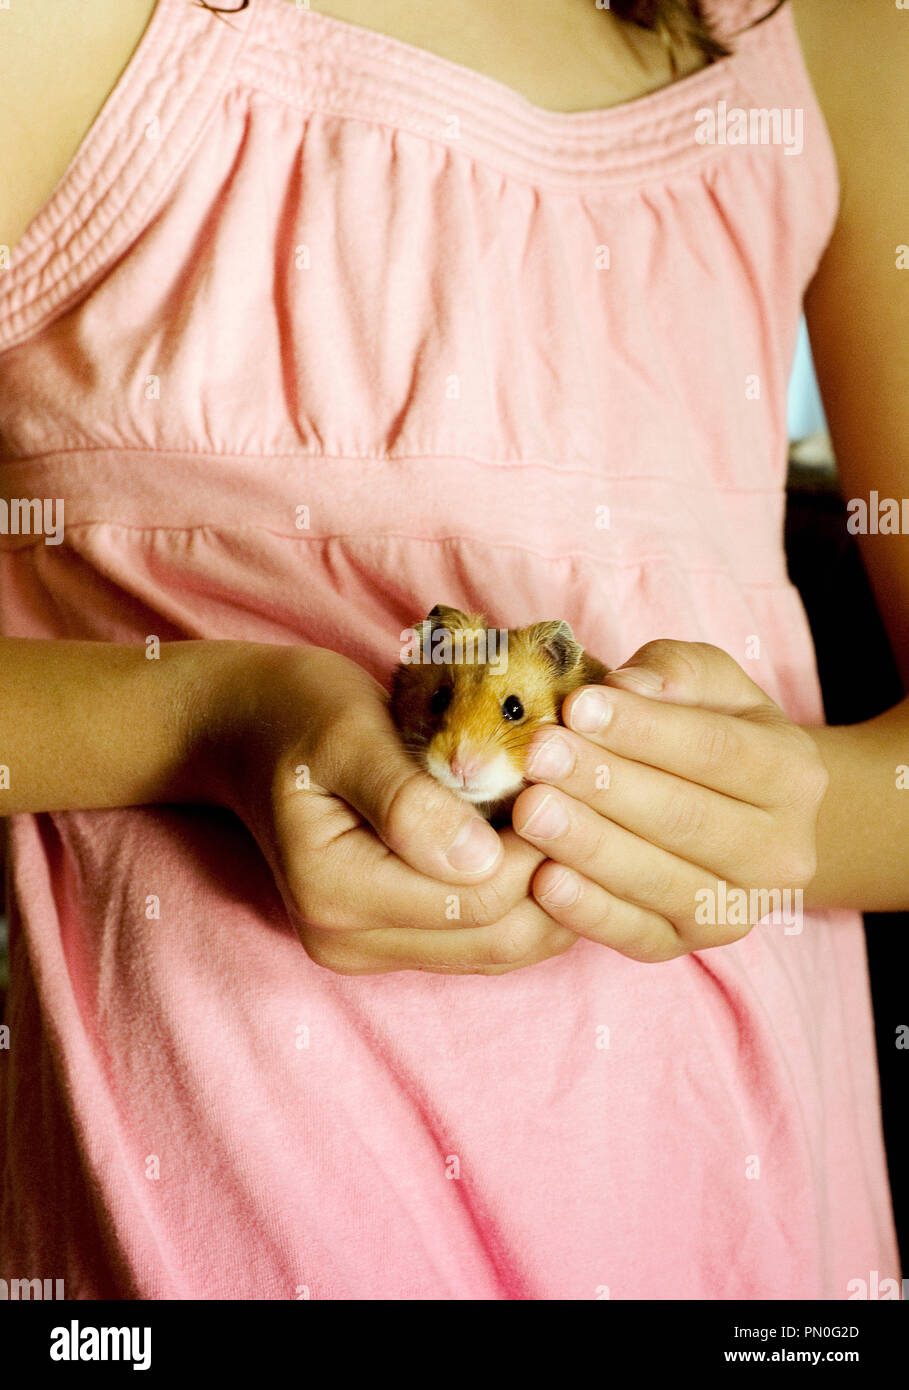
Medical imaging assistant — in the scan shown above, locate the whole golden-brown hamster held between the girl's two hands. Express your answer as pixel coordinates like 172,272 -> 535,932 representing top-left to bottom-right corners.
389,603 -> 609,824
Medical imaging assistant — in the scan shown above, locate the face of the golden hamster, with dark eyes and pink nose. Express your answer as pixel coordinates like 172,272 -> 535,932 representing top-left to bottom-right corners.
392,622 -> 560,808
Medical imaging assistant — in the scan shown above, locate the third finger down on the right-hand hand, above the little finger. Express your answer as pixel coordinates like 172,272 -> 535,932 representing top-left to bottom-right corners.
513,785 -> 756,951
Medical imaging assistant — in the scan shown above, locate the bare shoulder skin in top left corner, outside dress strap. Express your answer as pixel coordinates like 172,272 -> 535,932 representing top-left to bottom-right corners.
0,0 -> 156,246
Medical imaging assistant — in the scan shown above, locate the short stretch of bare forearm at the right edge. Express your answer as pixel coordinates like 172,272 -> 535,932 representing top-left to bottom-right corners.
805,699 -> 909,912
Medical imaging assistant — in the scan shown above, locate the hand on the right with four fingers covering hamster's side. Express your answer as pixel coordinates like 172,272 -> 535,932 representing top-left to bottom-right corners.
511,641 -> 827,962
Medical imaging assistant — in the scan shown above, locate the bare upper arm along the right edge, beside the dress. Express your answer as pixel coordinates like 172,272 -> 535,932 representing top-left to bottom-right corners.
791,0 -> 909,656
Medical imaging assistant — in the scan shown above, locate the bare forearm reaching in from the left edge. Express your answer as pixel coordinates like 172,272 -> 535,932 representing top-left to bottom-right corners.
0,637 -> 259,816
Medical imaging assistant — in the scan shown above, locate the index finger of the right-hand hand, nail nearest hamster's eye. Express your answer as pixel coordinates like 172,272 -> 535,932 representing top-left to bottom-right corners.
562,685 -> 803,808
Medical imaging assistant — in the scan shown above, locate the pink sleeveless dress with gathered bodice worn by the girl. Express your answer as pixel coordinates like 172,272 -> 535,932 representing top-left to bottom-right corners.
0,0 -> 899,1300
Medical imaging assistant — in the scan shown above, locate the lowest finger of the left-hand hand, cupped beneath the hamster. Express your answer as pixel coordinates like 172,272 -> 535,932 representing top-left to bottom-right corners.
300,898 -> 578,974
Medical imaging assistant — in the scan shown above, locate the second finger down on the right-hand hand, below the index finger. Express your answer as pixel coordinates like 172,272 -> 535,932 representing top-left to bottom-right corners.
525,730 -> 776,878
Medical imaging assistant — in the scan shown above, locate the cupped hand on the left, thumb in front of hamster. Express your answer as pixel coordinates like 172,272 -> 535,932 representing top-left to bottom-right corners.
206,645 -> 577,974
